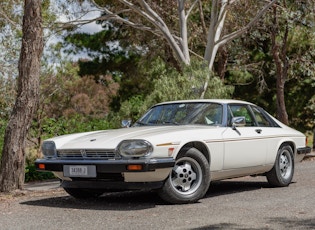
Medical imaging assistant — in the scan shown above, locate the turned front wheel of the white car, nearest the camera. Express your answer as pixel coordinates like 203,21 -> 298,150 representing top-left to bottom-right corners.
159,148 -> 210,204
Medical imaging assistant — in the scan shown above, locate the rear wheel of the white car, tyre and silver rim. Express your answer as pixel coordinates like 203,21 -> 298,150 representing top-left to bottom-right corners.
266,145 -> 294,187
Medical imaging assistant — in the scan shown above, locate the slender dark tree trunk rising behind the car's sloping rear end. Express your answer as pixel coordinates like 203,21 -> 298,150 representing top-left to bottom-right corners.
271,4 -> 289,125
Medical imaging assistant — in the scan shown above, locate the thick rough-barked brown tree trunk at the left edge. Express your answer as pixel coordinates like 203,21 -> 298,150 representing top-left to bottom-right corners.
0,0 -> 43,192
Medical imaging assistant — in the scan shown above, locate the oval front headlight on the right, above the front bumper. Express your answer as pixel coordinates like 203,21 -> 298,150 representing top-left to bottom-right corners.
117,140 -> 153,157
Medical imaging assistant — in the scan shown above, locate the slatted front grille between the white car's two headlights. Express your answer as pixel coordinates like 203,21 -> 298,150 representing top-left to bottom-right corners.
57,149 -> 120,160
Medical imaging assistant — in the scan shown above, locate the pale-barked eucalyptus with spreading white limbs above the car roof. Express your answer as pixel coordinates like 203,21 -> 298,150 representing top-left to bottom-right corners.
63,0 -> 276,97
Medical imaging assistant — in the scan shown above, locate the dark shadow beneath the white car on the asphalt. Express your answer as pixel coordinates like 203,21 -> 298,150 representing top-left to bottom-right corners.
21,177 -> 269,211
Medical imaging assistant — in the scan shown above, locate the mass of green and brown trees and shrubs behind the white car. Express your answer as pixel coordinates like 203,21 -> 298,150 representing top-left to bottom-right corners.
0,0 -> 315,181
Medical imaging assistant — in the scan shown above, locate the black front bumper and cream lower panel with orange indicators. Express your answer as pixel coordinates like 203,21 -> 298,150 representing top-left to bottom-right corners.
35,157 -> 175,187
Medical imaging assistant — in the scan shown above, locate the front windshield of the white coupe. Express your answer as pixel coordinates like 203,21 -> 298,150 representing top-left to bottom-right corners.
135,102 -> 222,126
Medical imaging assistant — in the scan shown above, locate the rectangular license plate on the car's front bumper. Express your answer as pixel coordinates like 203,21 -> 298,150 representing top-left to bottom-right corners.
63,165 -> 96,177
